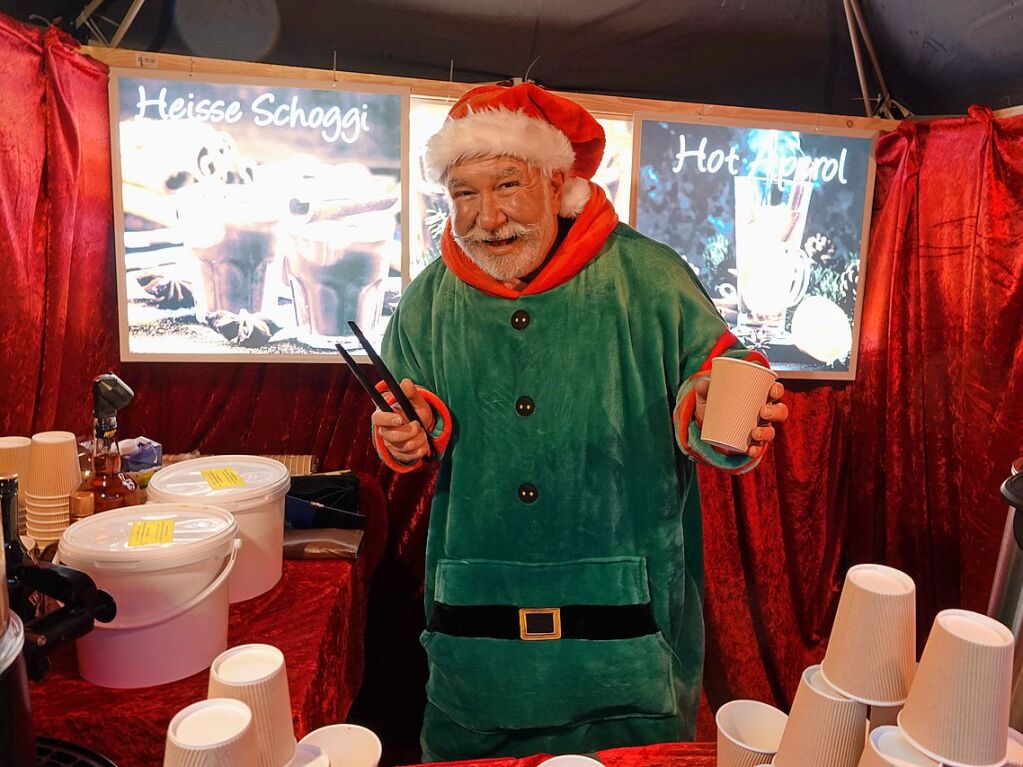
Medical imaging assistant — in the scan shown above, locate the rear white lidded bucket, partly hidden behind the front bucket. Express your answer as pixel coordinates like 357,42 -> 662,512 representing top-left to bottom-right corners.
147,455 -> 292,603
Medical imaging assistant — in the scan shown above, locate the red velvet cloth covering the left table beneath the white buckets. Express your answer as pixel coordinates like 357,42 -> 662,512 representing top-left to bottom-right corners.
30,477 -> 387,767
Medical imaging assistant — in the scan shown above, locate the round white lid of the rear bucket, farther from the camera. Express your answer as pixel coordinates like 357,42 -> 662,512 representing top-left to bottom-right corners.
146,455 -> 292,511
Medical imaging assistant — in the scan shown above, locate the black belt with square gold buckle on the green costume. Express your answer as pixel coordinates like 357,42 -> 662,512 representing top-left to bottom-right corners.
427,602 -> 658,639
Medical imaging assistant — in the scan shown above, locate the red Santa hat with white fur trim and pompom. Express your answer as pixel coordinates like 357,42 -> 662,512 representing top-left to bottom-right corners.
426,83 -> 604,218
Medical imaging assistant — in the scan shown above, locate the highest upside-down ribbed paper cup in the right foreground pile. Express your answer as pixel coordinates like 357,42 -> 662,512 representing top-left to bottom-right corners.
820,565 -> 917,707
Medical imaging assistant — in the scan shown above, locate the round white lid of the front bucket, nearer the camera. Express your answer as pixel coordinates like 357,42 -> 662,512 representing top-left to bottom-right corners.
57,503 -> 238,572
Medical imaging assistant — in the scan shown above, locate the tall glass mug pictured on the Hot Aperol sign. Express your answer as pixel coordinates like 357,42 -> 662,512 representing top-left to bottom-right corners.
735,176 -> 813,345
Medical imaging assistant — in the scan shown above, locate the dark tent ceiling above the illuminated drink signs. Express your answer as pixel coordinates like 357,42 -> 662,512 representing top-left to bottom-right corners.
0,0 -> 1023,115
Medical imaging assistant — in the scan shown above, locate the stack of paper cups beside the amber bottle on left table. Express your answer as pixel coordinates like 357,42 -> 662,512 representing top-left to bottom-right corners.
25,432 -> 82,547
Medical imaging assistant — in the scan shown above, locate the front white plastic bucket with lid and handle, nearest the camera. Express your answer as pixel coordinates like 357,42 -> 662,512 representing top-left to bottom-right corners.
58,503 -> 240,689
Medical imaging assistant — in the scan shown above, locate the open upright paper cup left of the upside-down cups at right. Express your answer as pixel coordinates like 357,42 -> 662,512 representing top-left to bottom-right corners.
714,701 -> 789,767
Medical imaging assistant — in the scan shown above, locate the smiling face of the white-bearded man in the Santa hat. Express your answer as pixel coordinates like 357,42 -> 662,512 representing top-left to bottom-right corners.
447,157 -> 565,280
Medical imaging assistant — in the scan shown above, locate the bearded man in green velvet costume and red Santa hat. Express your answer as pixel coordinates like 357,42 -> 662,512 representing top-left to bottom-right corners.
372,84 -> 787,761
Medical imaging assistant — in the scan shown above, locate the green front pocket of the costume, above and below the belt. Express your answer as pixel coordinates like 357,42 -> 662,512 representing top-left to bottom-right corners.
422,557 -> 677,732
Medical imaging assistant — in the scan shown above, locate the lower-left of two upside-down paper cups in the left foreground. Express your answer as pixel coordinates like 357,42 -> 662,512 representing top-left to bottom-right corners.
164,698 -> 259,767
